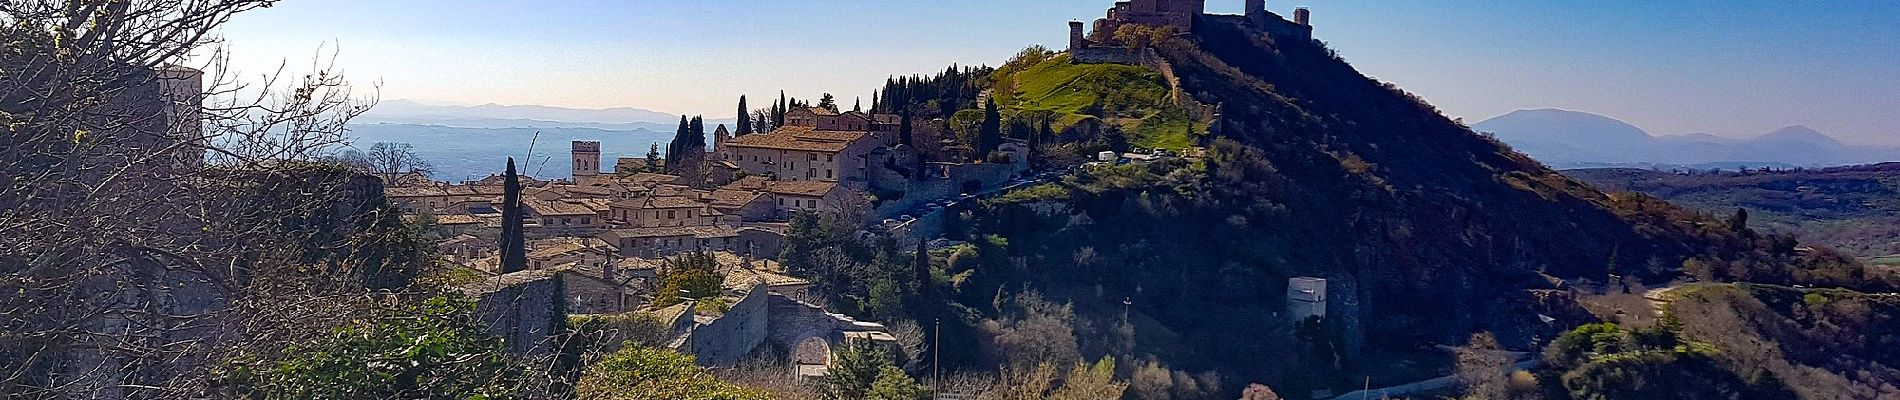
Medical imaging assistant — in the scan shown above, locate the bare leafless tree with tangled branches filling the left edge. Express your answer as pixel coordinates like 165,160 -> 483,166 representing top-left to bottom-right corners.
0,0 -> 459,398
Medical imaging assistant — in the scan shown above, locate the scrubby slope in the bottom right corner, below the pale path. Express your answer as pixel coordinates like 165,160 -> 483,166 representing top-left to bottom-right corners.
1539,284 -> 1900,400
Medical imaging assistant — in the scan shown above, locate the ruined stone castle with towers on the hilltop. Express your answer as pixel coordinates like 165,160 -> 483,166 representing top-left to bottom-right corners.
1068,0 -> 1313,64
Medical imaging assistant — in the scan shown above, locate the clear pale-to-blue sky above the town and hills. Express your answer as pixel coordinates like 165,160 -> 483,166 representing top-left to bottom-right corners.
211,0 -> 1900,144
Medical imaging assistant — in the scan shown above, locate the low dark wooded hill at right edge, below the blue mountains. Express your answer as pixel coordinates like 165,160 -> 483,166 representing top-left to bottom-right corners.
1564,163 -> 1900,258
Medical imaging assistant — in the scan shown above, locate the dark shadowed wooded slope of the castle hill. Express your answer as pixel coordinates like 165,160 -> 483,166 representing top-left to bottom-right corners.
872,15 -> 1885,398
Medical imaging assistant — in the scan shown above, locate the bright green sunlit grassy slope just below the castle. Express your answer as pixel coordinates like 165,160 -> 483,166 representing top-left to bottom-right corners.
992,55 -> 1207,150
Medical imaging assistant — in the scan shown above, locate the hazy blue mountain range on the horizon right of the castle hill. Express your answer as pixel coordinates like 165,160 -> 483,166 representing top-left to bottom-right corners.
1471,108 -> 1900,169
